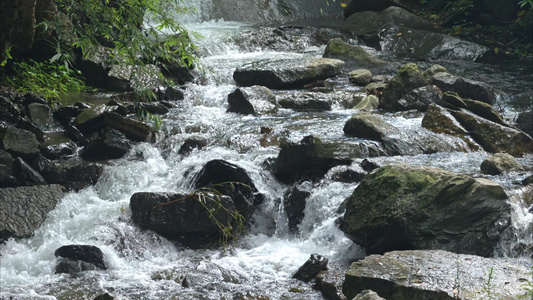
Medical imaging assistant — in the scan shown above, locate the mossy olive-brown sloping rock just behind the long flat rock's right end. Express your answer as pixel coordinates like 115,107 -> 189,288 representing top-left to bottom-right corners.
323,38 -> 386,67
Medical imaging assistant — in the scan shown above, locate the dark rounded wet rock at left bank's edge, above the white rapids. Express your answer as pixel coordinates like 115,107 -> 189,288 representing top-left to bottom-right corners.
80,129 -> 131,161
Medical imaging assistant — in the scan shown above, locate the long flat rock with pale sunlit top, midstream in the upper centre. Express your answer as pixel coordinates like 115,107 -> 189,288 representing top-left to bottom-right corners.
233,58 -> 344,89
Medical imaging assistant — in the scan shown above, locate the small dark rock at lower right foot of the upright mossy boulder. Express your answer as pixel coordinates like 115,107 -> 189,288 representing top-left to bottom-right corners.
392,85 -> 442,111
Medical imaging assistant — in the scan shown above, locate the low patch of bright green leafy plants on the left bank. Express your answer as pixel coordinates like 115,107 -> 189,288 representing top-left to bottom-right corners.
2,60 -> 85,103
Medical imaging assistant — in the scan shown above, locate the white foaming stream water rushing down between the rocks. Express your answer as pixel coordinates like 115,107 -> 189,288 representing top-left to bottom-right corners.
0,0 -> 533,299
